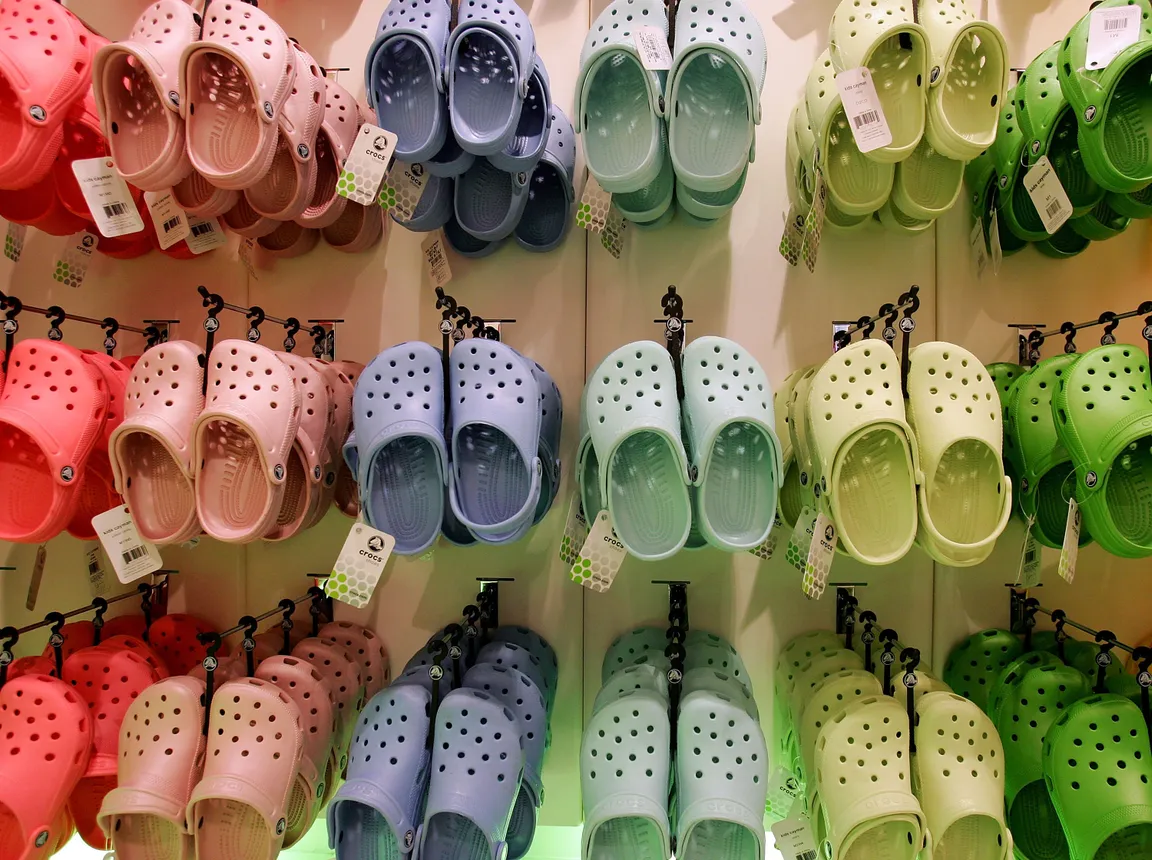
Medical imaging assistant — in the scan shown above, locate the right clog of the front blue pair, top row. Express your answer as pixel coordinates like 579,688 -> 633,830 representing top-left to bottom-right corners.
446,0 -> 536,155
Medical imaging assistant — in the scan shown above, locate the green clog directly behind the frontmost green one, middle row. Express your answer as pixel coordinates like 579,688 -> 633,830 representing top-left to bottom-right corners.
1005,353 -> 1092,549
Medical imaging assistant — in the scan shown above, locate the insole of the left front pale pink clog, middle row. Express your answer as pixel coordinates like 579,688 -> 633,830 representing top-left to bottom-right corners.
122,433 -> 196,540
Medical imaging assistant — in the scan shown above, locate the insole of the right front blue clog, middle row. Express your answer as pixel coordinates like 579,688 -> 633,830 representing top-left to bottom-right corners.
456,424 -> 532,526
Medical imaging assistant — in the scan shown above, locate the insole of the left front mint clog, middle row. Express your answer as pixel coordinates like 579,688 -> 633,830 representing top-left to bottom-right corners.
607,431 -> 692,555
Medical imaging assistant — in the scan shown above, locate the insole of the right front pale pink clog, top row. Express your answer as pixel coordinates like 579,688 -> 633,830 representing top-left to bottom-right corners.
187,52 -> 263,173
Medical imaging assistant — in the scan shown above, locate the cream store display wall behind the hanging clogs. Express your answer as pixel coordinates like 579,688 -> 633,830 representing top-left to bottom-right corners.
0,0 -> 1152,851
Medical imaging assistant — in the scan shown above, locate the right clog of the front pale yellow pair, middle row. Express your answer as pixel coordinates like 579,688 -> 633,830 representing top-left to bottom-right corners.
908,342 -> 1011,566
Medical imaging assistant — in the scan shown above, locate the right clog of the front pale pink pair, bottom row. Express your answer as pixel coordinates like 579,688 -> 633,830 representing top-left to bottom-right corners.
188,678 -> 303,860
